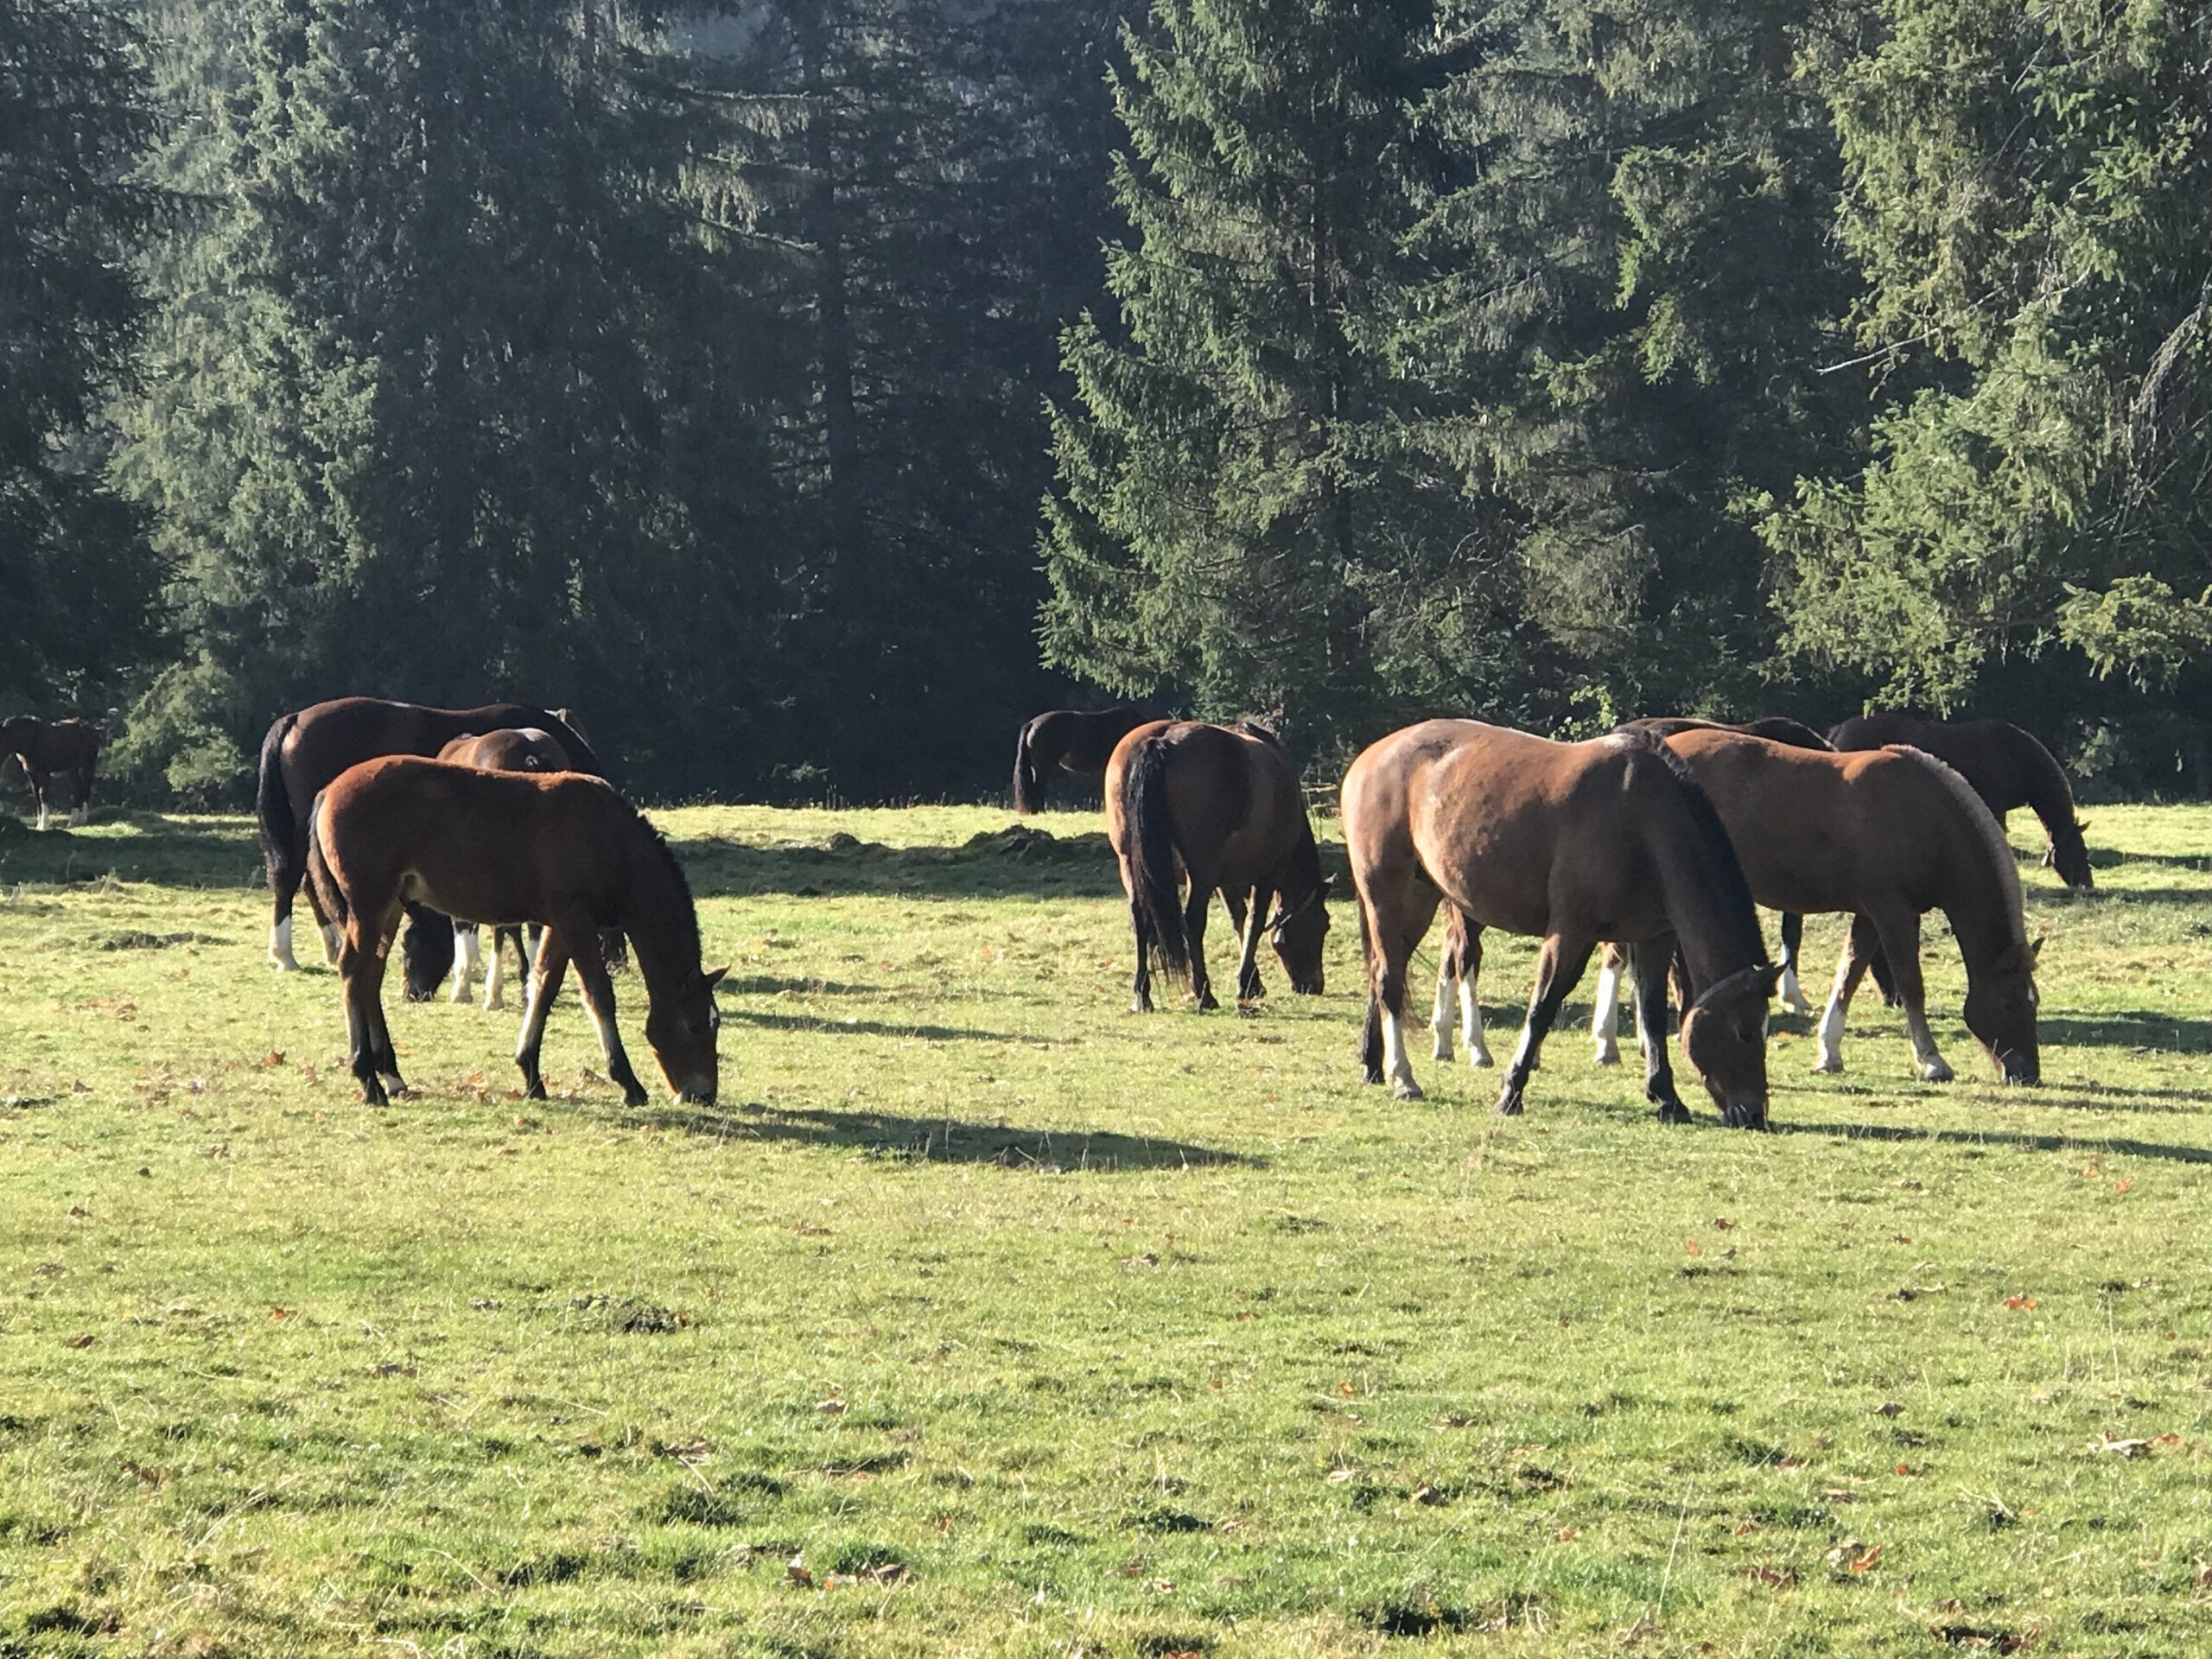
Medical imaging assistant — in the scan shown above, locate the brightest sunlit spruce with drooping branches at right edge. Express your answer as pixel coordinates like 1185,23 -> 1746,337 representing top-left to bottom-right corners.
1767,0 -> 2212,708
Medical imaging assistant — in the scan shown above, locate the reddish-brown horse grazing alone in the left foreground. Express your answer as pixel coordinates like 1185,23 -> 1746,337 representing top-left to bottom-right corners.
308,754 -> 728,1106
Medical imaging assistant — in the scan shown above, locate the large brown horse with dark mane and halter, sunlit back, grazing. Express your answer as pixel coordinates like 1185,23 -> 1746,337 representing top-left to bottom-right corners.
1343,721 -> 1781,1128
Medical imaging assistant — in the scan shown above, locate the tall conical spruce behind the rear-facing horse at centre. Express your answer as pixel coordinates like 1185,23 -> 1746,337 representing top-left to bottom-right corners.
1044,0 -> 1510,747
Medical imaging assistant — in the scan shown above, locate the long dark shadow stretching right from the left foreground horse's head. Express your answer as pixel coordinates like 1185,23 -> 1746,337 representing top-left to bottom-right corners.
632,1106 -> 1265,1173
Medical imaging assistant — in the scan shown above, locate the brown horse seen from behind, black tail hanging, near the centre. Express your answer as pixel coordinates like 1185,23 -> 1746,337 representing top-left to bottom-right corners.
1106,721 -> 1330,1013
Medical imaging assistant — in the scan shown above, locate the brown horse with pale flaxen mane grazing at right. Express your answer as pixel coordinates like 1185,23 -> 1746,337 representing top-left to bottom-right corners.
1601,732 -> 2042,1084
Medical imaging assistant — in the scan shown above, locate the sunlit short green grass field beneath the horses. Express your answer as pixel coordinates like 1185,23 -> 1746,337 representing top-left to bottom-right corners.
0,807 -> 2212,1659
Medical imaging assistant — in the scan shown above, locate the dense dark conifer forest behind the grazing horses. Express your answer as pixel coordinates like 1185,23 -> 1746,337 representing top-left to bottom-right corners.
0,0 -> 2212,803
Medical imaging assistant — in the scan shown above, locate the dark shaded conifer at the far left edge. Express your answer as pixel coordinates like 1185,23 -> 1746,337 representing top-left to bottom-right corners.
0,0 -> 163,708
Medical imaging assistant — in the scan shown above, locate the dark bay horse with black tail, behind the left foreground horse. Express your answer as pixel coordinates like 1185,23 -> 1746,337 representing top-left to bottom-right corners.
254,696 -> 604,987
